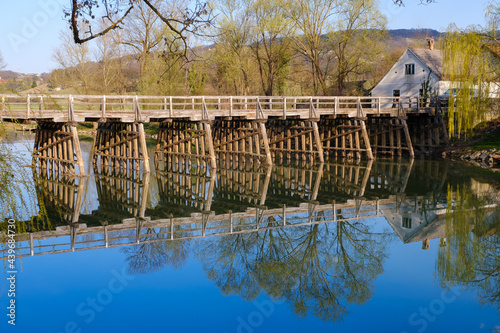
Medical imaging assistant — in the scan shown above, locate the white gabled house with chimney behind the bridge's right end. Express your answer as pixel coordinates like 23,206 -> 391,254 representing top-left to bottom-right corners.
371,39 -> 450,97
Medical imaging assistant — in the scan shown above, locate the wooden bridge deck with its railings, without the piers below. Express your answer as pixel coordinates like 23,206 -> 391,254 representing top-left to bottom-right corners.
0,95 -> 436,122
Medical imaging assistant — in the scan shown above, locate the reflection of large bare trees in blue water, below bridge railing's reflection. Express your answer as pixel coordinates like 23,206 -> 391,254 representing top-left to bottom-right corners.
193,214 -> 389,321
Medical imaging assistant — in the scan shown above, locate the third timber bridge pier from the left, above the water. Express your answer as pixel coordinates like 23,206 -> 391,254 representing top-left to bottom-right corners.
155,119 -> 217,170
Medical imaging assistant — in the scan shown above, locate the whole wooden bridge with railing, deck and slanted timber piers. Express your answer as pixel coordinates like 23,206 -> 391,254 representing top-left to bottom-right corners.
0,95 -> 447,174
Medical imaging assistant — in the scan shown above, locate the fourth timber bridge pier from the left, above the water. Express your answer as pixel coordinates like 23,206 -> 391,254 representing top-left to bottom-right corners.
213,118 -> 272,165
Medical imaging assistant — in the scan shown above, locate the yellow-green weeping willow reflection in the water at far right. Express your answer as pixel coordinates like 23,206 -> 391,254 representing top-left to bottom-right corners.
436,185 -> 500,310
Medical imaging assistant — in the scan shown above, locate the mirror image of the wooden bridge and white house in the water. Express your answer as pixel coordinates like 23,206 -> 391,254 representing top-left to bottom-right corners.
2,156 -> 488,258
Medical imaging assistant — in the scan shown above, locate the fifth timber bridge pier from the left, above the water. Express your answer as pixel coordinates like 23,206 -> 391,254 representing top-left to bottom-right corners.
266,118 -> 324,162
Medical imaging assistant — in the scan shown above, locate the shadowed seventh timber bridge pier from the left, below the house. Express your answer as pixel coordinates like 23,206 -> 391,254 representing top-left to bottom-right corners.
368,116 -> 415,158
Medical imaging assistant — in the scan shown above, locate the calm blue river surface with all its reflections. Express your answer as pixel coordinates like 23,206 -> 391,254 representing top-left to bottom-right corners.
0,131 -> 500,333
